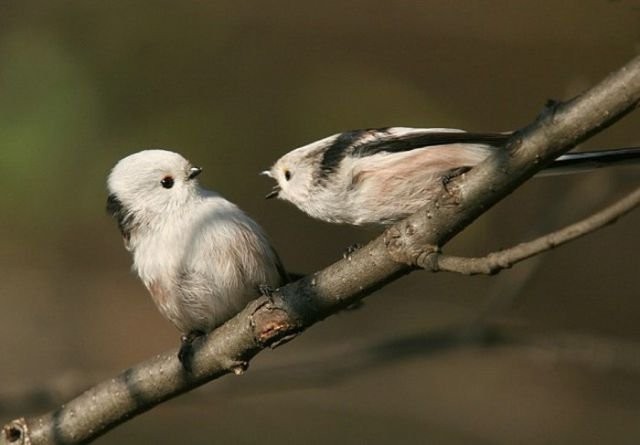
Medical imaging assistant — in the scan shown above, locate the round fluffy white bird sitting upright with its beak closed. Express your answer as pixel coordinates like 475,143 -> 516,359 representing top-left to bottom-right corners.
107,150 -> 287,369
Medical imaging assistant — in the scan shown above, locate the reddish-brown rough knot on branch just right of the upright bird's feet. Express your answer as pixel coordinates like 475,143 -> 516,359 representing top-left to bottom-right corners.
250,291 -> 302,348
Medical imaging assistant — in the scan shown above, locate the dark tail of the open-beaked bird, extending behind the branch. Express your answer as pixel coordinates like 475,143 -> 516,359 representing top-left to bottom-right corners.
539,147 -> 640,176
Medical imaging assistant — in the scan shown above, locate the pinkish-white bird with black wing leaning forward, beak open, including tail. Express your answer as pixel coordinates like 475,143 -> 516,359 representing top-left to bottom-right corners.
263,127 -> 640,225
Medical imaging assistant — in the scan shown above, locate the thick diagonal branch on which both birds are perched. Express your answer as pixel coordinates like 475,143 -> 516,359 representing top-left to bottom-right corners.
5,53 -> 640,445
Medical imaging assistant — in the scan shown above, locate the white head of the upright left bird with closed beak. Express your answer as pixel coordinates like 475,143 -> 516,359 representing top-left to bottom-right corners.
107,150 -> 202,238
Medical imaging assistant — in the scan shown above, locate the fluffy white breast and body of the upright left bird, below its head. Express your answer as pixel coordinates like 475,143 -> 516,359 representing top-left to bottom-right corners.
131,194 -> 280,332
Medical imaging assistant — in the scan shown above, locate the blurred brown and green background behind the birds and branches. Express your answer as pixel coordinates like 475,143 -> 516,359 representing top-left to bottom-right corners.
0,0 -> 640,444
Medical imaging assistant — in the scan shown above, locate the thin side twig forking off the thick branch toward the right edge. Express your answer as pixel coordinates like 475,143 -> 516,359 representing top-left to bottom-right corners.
418,184 -> 640,275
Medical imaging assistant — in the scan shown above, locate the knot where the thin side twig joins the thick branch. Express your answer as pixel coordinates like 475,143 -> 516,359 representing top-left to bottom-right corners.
384,220 -> 440,267
